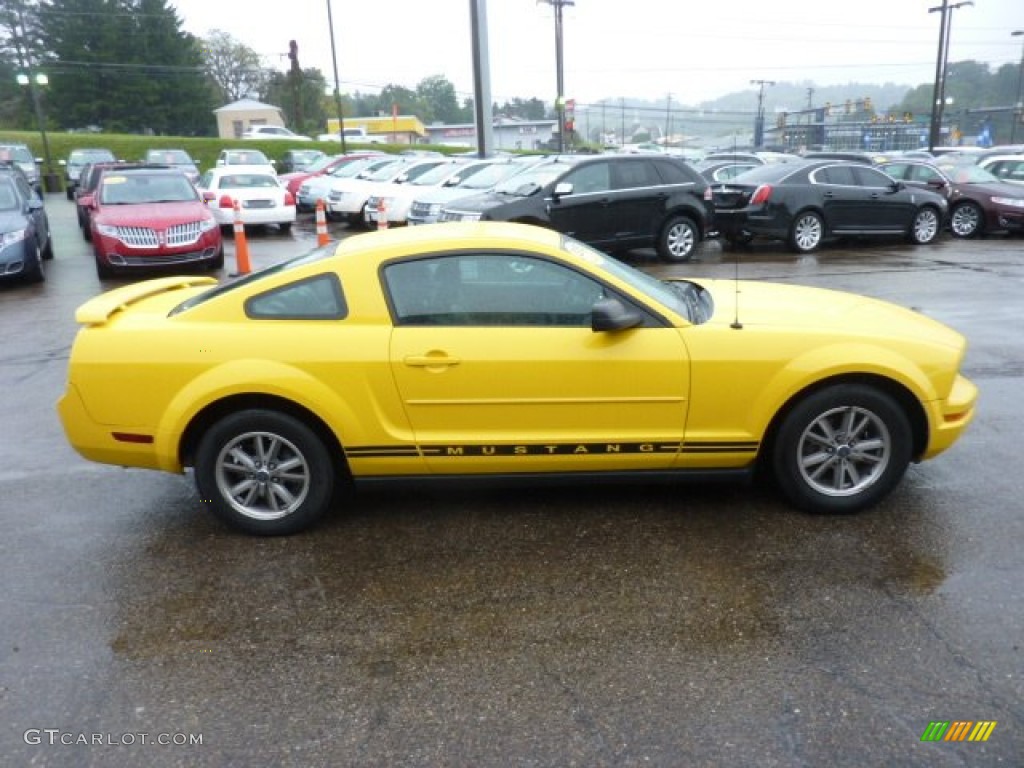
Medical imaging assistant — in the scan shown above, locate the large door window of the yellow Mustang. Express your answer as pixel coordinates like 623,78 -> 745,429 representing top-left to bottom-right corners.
384,253 -> 605,327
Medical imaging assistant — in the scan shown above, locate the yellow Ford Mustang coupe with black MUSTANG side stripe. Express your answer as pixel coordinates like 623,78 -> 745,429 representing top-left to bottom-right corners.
58,222 -> 977,535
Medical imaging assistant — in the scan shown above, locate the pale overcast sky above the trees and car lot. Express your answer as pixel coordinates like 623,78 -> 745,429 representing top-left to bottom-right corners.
170,0 -> 1024,104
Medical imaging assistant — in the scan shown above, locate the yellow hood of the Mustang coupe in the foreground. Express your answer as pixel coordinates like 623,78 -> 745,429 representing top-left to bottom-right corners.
700,280 -> 965,348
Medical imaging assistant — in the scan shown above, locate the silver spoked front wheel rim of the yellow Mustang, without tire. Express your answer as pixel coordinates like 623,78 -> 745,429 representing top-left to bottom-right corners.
797,406 -> 893,497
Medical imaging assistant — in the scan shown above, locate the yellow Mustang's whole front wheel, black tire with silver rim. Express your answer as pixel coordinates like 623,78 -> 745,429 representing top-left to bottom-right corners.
771,384 -> 911,514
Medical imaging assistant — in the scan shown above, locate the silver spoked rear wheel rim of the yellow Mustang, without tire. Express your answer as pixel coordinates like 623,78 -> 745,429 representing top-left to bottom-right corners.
215,432 -> 312,520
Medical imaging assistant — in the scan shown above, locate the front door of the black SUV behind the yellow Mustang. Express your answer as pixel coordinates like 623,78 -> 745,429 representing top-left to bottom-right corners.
544,160 -> 615,246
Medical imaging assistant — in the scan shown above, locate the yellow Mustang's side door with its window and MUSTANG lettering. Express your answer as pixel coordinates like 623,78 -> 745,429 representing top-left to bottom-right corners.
383,253 -> 689,473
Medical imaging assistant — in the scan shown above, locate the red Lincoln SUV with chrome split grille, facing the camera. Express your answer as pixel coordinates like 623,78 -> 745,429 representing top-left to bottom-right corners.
89,168 -> 224,279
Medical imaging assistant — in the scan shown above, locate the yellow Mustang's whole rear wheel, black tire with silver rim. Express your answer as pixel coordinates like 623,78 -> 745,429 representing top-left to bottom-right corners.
196,409 -> 335,536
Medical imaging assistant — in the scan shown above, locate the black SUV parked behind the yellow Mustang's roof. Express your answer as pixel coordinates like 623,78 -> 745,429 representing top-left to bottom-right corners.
440,155 -> 715,261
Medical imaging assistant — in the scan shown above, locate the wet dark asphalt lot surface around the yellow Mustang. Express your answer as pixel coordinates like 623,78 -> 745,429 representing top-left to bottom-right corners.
0,196 -> 1024,768
